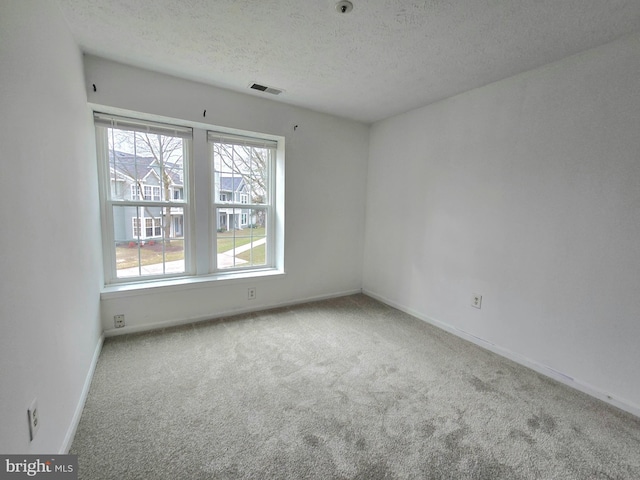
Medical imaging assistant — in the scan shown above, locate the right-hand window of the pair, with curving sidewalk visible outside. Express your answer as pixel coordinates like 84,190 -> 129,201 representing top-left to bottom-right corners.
208,132 -> 277,271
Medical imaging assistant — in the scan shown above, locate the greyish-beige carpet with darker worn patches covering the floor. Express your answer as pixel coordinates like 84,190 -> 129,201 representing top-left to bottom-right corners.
71,295 -> 640,480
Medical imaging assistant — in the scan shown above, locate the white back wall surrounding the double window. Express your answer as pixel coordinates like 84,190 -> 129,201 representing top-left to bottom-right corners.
85,56 -> 369,333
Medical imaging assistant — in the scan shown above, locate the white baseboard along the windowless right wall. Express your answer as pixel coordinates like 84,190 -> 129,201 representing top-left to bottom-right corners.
362,289 -> 640,417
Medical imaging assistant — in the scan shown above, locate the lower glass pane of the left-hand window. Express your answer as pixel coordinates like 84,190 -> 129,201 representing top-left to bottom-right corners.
113,206 -> 185,278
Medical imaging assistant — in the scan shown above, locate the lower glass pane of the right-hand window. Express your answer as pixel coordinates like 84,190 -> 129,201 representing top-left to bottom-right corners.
216,208 -> 267,269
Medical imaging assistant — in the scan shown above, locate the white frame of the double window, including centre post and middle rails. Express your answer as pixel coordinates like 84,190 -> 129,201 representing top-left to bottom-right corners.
96,107 -> 285,290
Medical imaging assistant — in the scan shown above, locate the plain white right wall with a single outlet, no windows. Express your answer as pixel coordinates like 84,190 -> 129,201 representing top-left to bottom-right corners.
363,31 -> 640,414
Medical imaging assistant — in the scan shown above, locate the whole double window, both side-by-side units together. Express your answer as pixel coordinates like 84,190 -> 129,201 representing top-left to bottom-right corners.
94,112 -> 284,291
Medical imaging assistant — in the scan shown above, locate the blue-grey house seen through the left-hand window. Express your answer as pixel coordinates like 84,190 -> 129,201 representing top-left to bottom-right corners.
109,151 -> 184,243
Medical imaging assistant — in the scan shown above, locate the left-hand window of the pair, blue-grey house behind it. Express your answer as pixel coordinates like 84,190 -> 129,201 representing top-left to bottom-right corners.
95,114 -> 192,283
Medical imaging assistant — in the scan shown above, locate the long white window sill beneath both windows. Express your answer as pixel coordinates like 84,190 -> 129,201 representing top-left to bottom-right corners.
100,268 -> 285,300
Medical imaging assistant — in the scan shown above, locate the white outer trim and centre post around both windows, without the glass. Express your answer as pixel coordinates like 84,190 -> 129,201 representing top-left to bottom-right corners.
90,109 -> 285,290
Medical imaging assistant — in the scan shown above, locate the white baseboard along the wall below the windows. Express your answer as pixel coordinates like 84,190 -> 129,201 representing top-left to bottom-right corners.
104,288 -> 362,337
